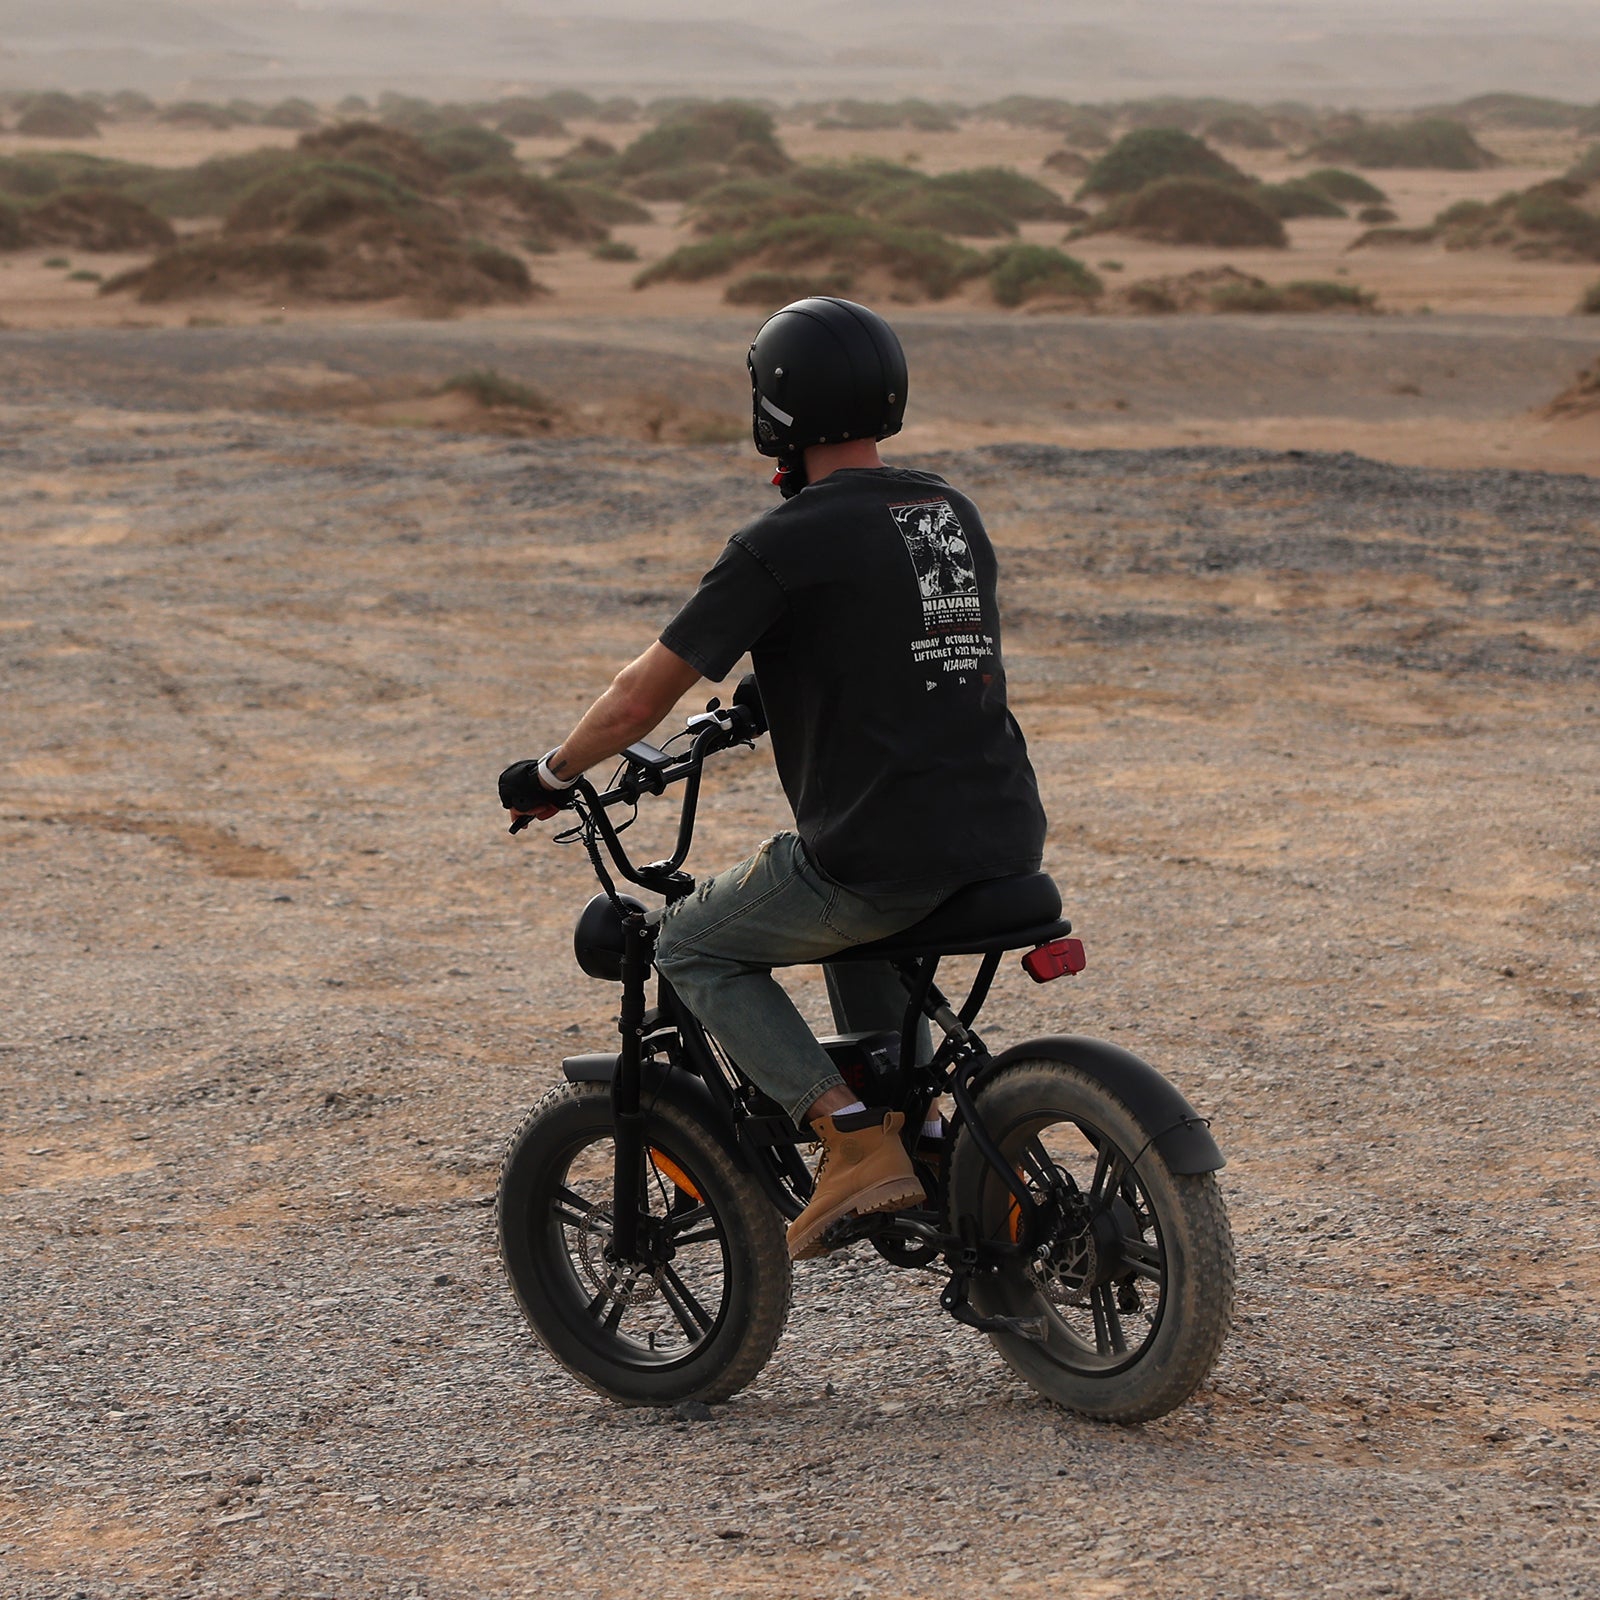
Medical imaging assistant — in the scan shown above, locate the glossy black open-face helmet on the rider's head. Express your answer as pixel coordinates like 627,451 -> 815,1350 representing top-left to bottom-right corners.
746,296 -> 906,466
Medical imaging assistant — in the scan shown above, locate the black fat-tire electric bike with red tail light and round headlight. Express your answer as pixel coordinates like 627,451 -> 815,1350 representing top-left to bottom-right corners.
496,678 -> 1234,1422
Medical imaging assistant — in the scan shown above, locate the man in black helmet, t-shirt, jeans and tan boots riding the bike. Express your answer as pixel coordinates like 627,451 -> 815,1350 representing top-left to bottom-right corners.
501,298 -> 1045,1259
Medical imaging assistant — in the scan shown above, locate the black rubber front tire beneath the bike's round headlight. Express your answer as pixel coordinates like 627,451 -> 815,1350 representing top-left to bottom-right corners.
496,1083 -> 792,1405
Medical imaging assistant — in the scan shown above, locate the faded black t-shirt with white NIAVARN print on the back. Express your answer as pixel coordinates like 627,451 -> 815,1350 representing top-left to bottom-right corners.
661,467 -> 1045,893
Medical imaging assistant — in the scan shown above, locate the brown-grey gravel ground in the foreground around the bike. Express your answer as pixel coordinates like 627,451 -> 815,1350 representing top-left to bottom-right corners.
0,356 -> 1600,1600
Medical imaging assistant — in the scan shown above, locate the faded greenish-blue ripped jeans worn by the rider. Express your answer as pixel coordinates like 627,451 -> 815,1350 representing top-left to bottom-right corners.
656,834 -> 950,1128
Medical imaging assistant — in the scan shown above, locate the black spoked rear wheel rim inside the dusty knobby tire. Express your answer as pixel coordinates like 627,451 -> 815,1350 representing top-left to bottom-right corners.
986,1117 -> 1170,1378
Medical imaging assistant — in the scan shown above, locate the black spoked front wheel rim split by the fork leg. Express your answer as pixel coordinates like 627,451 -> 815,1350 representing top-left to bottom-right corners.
530,1134 -> 731,1371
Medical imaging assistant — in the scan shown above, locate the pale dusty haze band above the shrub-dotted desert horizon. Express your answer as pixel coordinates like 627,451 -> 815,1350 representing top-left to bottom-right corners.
9,0 -> 1600,107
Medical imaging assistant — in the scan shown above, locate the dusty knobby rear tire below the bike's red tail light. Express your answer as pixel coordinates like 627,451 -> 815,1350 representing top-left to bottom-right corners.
949,1059 -> 1234,1422
